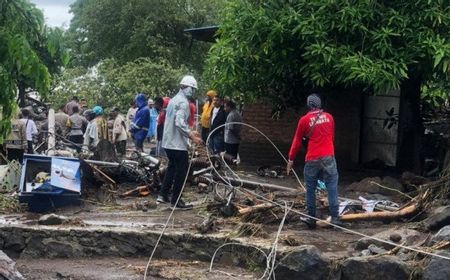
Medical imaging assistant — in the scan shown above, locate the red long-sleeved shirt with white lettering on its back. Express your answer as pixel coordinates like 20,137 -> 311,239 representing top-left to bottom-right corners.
289,110 -> 334,161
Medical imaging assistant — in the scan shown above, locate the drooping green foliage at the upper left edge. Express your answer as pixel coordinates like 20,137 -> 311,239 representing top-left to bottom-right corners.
0,0 -> 68,143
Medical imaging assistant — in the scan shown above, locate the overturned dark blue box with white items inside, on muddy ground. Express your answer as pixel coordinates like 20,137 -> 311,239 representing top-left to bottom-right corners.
19,155 -> 81,212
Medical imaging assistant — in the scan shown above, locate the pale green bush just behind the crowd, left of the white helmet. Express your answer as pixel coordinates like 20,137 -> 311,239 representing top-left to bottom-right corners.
49,58 -> 188,111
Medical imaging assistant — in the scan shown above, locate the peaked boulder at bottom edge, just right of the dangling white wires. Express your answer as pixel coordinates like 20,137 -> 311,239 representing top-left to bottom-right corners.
275,245 -> 330,280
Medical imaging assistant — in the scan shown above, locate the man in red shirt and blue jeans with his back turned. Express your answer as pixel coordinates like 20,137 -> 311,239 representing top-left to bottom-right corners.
287,94 -> 342,229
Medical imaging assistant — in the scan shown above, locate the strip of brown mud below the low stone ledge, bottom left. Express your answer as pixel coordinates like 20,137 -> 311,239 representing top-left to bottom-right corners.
17,258 -> 258,280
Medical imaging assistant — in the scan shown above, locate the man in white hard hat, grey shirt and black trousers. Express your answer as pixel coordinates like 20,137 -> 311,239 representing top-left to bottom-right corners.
157,75 -> 203,209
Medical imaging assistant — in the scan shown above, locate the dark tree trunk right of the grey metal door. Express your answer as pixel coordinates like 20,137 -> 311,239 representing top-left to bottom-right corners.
397,78 -> 424,174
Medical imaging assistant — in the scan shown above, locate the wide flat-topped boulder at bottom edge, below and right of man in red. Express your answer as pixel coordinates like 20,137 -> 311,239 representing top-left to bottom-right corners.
341,256 -> 411,280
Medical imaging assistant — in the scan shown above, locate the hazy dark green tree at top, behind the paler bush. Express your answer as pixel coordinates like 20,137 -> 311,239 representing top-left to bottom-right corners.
68,0 -> 224,69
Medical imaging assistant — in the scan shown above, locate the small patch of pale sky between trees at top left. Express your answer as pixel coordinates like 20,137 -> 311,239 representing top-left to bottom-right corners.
30,0 -> 75,28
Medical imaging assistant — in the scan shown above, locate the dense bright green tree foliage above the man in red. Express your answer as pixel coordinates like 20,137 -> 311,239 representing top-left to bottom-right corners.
205,0 -> 450,106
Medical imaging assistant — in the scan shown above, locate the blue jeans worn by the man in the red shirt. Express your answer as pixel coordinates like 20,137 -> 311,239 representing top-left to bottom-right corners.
303,156 -> 339,218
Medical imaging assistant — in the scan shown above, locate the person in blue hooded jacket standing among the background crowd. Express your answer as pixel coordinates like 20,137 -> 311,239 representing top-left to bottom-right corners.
130,93 -> 150,152
